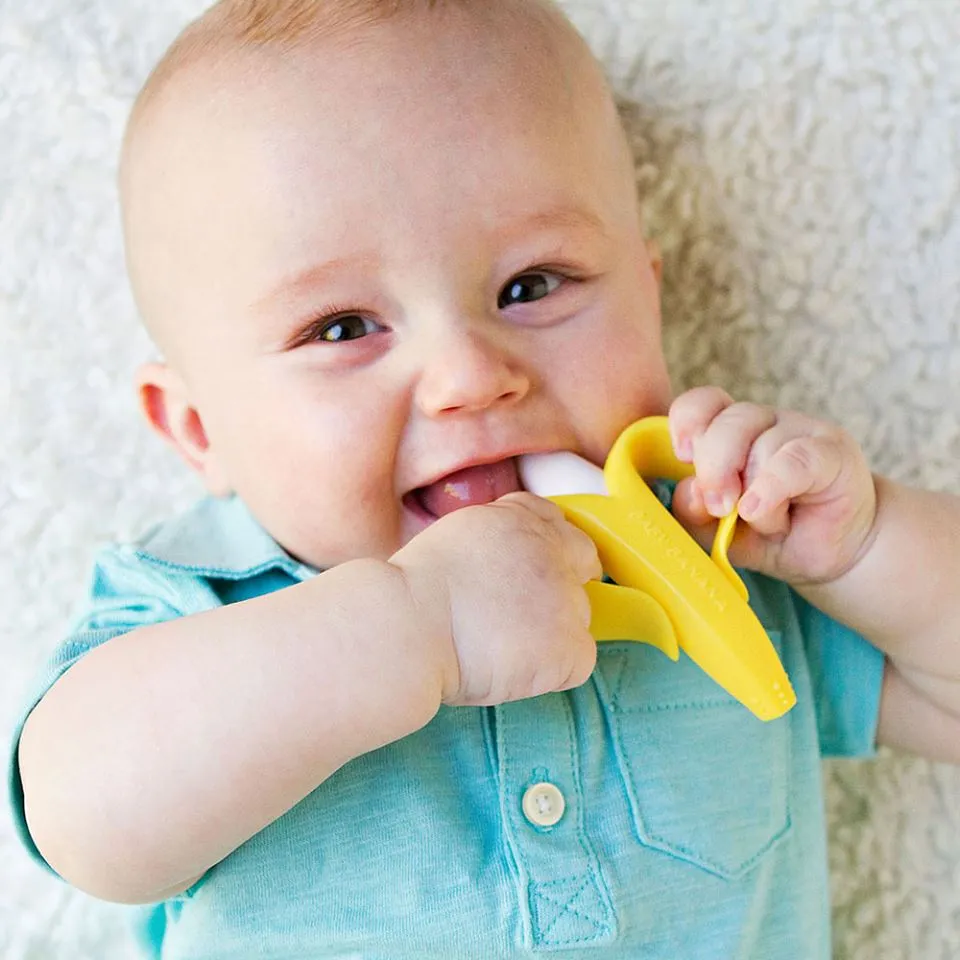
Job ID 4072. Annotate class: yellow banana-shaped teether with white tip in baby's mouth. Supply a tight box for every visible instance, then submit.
[521,417,796,720]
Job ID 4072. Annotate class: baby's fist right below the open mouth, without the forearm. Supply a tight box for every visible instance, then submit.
[391,493,602,706]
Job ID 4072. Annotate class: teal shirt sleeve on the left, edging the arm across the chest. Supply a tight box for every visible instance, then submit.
[8,547,189,869]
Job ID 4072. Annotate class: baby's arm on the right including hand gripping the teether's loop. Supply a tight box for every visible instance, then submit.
[670,387,960,763]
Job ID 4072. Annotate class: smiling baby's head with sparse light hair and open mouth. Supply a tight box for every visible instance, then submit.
[121,0,669,567]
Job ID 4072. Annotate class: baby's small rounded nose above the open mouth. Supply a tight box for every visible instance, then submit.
[416,327,530,417]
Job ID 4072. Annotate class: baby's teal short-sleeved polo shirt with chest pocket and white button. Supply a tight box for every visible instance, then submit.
[10,498,884,960]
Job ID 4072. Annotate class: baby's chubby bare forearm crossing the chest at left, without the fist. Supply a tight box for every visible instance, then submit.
[20,561,441,902]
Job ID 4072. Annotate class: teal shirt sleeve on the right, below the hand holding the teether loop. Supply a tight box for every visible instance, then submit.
[791,591,886,757]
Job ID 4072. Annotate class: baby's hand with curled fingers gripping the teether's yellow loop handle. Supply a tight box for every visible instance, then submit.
[670,387,877,586]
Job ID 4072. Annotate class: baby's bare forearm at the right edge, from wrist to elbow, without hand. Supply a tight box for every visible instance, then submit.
[798,478,960,696]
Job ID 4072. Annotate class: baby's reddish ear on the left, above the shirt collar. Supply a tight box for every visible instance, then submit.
[136,363,232,497]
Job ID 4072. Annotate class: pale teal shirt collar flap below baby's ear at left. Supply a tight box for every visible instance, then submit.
[134,496,318,580]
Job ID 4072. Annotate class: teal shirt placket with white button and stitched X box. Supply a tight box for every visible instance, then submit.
[494,694,616,951]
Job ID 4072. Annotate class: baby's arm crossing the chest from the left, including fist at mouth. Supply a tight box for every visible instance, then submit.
[19,494,600,903]
